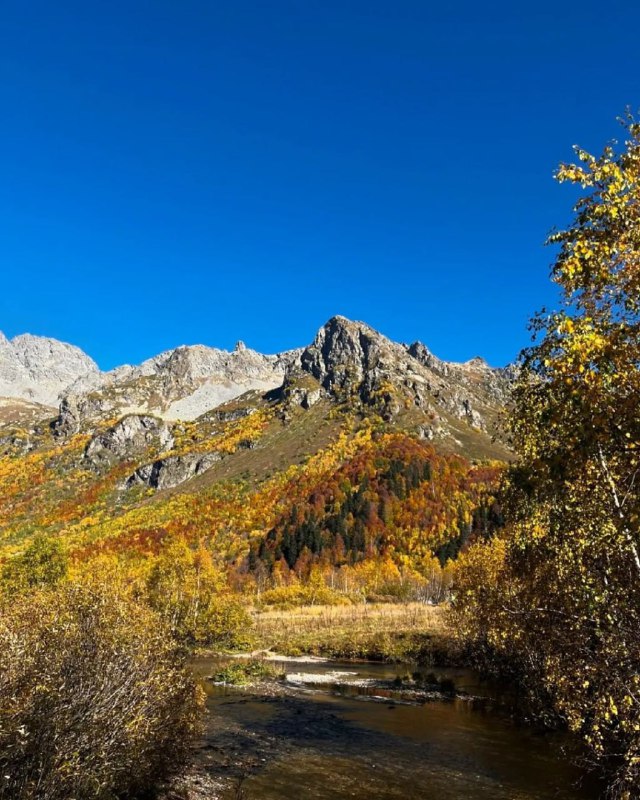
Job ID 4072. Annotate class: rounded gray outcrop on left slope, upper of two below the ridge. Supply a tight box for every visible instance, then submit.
[84,415,174,469]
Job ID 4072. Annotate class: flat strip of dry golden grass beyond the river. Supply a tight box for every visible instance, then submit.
[253,603,453,664]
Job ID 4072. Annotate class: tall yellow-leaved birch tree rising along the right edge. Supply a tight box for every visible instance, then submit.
[457,114,640,798]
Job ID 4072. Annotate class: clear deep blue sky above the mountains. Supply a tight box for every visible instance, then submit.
[0,0,640,368]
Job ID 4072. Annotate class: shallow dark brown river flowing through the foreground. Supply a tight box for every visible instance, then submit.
[190,659,599,800]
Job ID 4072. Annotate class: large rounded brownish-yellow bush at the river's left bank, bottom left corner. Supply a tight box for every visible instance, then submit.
[0,584,201,800]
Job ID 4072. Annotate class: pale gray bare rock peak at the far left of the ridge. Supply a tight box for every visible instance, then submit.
[0,333,98,407]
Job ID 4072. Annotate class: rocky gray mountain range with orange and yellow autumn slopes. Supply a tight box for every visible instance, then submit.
[0,317,514,582]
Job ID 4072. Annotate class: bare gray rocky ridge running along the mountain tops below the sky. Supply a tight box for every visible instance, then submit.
[0,317,514,450]
